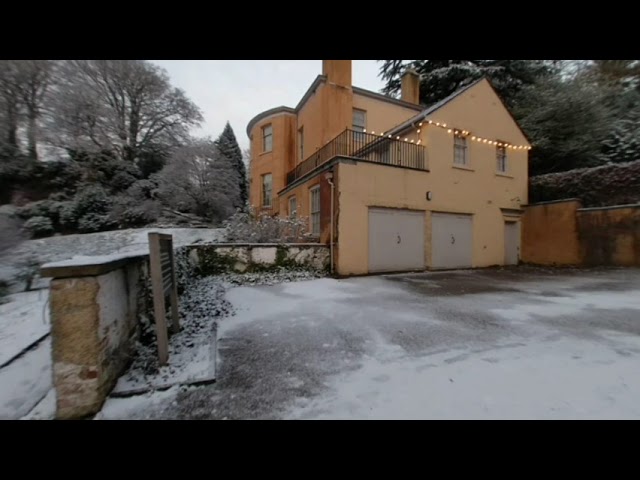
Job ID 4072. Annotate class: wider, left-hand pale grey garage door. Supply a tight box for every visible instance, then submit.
[369,208,425,273]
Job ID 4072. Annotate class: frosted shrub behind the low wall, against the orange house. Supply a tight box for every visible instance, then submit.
[224,211,316,243]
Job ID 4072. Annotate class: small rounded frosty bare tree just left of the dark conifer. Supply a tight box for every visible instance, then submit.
[157,139,240,221]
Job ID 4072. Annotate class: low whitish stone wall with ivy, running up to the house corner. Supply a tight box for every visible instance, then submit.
[184,243,330,275]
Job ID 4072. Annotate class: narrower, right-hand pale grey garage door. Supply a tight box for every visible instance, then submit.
[431,213,473,268]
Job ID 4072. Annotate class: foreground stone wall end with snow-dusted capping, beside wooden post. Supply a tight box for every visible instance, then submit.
[41,255,148,419]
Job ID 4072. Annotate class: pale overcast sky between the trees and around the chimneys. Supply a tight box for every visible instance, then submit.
[154,60,383,149]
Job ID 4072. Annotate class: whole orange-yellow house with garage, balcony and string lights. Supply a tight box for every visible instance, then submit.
[247,60,531,275]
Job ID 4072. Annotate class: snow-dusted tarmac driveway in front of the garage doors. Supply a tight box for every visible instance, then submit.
[101,268,640,419]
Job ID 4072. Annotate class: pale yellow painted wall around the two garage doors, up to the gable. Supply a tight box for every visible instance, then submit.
[337,82,528,275]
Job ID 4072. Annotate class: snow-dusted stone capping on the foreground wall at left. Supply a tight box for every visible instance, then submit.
[40,252,149,278]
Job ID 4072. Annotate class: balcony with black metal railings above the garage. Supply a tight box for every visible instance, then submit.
[287,129,428,185]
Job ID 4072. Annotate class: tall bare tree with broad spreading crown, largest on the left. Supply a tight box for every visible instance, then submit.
[54,60,202,161]
